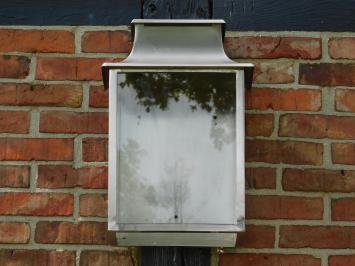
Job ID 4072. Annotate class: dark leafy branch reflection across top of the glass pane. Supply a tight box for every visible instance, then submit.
[120,73,235,149]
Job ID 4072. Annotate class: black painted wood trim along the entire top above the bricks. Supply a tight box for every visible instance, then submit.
[0,0,355,32]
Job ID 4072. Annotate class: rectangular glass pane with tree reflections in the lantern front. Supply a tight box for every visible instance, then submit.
[118,73,236,224]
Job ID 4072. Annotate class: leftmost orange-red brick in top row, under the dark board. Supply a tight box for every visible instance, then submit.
[0,29,75,53]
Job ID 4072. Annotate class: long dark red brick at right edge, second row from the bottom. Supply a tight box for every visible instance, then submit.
[279,225,355,249]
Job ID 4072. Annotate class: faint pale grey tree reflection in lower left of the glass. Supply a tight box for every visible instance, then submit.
[119,139,191,223]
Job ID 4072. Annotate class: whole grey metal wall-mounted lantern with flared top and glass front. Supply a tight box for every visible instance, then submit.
[102,20,253,247]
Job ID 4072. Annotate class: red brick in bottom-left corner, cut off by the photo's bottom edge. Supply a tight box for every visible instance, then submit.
[0,249,75,266]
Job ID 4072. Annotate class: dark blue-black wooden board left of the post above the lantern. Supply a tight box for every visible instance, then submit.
[0,0,141,25]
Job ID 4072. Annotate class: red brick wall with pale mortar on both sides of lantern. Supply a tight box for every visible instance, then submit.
[0,27,355,266]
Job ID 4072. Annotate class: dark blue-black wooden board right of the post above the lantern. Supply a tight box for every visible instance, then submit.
[213,0,355,31]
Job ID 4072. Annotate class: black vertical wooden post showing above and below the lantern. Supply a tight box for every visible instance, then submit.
[140,0,212,266]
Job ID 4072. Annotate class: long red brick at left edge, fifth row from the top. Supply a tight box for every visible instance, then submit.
[0,138,74,161]
